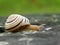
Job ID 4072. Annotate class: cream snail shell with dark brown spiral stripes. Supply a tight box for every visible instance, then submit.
[5,14,30,32]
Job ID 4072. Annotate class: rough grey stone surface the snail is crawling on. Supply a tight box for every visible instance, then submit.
[0,14,60,45]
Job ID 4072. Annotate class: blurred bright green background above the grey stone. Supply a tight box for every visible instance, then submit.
[0,0,60,16]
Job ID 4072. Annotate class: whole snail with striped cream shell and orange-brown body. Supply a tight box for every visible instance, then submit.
[5,14,45,32]
